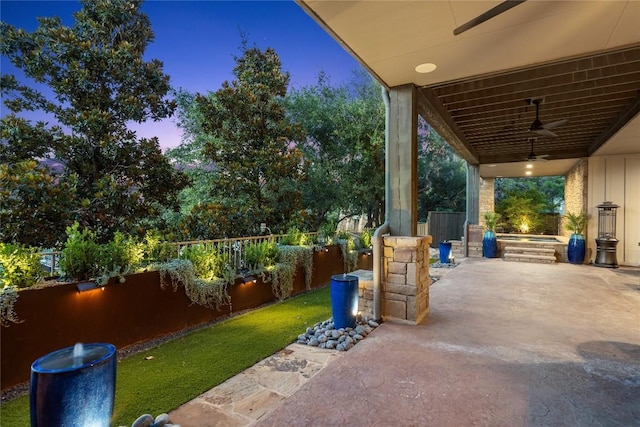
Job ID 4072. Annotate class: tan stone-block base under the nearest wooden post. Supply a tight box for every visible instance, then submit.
[381,236,431,325]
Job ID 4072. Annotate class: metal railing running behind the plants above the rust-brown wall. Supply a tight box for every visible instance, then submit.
[40,232,318,276]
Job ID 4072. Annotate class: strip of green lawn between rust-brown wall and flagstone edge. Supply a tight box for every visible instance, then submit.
[0,287,331,427]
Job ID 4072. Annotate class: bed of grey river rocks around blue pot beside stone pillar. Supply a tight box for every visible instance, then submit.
[296,316,379,351]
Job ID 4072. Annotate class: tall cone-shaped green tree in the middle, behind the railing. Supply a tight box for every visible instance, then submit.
[175,41,305,238]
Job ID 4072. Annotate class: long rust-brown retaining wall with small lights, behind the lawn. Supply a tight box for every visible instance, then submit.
[0,245,372,390]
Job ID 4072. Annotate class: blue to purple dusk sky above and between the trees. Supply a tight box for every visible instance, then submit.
[0,0,359,148]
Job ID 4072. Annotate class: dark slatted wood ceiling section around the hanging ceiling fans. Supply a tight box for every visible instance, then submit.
[420,46,640,164]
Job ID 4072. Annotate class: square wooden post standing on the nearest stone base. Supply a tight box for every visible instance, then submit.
[387,84,418,236]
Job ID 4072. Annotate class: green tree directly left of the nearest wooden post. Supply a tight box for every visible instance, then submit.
[287,71,385,229]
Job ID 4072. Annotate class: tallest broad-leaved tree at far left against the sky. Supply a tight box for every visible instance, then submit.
[0,0,186,244]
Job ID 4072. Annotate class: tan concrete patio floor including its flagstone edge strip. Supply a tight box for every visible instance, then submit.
[170,258,640,427]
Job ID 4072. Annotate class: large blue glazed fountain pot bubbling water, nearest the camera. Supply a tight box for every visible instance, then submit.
[29,343,117,427]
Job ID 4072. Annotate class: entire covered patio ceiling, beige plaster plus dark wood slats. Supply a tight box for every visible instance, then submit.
[297,0,640,177]
